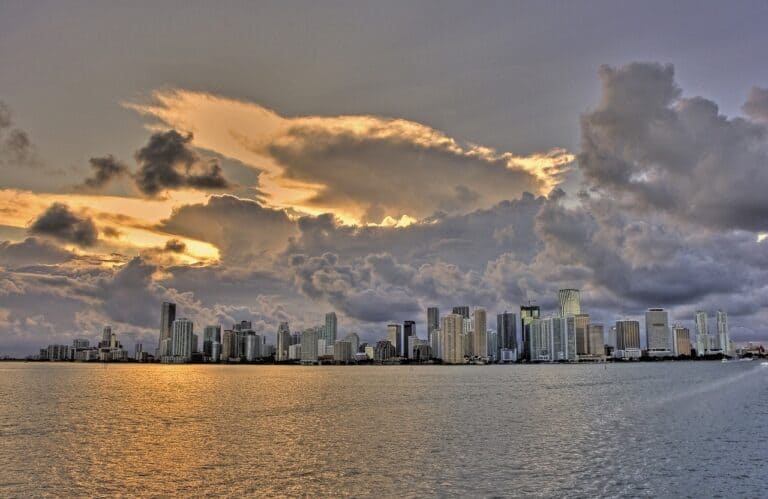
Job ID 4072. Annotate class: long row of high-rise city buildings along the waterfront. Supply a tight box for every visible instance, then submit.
[39,289,733,364]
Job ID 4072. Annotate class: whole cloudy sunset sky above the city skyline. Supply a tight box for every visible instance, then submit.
[0,0,768,355]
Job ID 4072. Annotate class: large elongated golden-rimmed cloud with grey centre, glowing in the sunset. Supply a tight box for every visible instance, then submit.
[129,90,573,223]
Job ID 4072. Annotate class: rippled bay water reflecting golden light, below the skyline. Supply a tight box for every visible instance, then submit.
[0,361,768,498]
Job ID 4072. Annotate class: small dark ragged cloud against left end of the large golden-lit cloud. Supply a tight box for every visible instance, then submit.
[135,130,229,196]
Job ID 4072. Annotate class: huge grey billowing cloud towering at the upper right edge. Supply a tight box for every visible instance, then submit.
[578,63,768,231]
